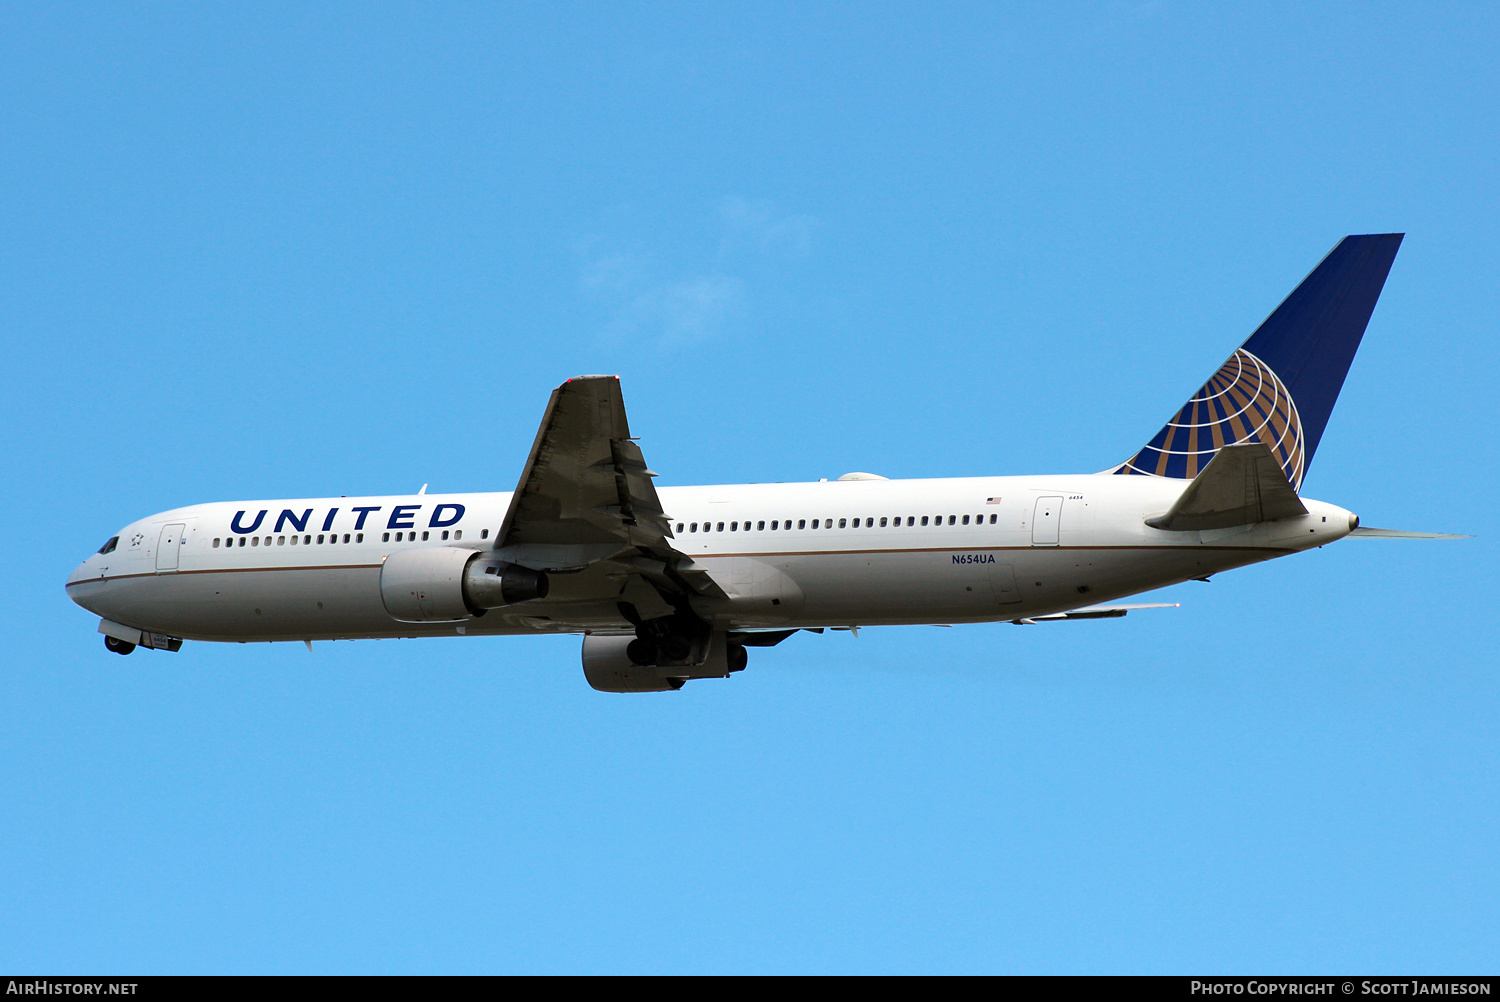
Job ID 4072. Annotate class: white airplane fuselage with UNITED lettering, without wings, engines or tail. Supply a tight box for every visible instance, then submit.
[68,474,1355,642]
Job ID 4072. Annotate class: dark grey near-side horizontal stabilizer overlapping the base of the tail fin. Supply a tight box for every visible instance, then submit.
[1146,441,1308,533]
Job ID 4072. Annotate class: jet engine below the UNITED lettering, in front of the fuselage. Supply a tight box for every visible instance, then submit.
[380,546,548,623]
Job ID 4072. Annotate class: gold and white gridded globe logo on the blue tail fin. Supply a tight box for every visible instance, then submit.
[1116,348,1305,491]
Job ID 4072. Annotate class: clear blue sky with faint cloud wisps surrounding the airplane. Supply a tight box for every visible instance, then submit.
[0,3,1500,974]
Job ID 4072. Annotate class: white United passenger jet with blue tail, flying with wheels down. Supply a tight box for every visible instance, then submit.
[66,234,1460,693]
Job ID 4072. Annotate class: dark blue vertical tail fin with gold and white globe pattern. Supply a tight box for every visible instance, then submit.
[1115,233,1406,491]
